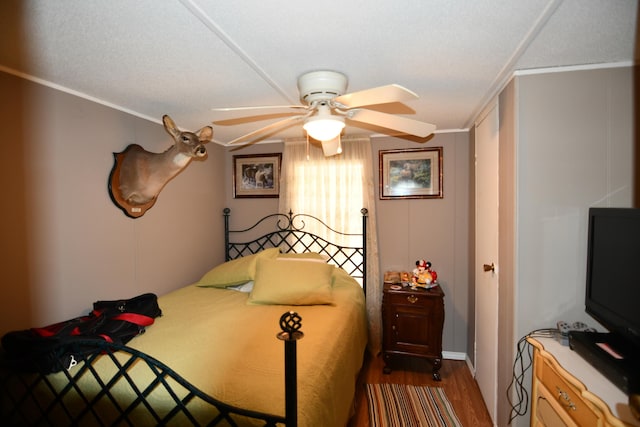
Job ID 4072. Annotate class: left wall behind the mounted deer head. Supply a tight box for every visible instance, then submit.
[0,73,224,334]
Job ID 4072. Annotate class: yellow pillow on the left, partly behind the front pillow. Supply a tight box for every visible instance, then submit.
[197,248,280,288]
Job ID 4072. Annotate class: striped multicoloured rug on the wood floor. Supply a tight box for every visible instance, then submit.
[366,384,462,427]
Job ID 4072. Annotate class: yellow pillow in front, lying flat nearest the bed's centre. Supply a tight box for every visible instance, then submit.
[248,258,335,305]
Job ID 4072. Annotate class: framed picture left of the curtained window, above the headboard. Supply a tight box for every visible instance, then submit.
[233,153,282,199]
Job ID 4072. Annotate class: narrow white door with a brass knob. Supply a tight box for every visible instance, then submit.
[474,104,499,424]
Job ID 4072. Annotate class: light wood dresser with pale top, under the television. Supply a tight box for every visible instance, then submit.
[527,338,640,427]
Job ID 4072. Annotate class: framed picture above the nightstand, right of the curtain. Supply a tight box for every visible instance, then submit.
[379,147,443,199]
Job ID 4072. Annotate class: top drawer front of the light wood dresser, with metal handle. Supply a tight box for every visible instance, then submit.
[536,357,600,426]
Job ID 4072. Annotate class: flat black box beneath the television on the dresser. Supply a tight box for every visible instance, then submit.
[569,331,640,395]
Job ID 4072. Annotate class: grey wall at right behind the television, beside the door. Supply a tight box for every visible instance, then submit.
[496,68,634,426]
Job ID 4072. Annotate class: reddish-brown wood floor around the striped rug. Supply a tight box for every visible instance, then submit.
[348,356,492,427]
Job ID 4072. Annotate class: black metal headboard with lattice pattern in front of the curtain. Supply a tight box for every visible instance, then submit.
[223,208,368,295]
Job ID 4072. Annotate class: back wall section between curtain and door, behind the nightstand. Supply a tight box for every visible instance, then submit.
[372,132,473,357]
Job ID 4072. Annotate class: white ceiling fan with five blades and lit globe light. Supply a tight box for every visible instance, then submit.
[213,70,436,156]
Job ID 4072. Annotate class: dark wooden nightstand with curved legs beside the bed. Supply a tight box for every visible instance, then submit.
[382,283,444,381]
